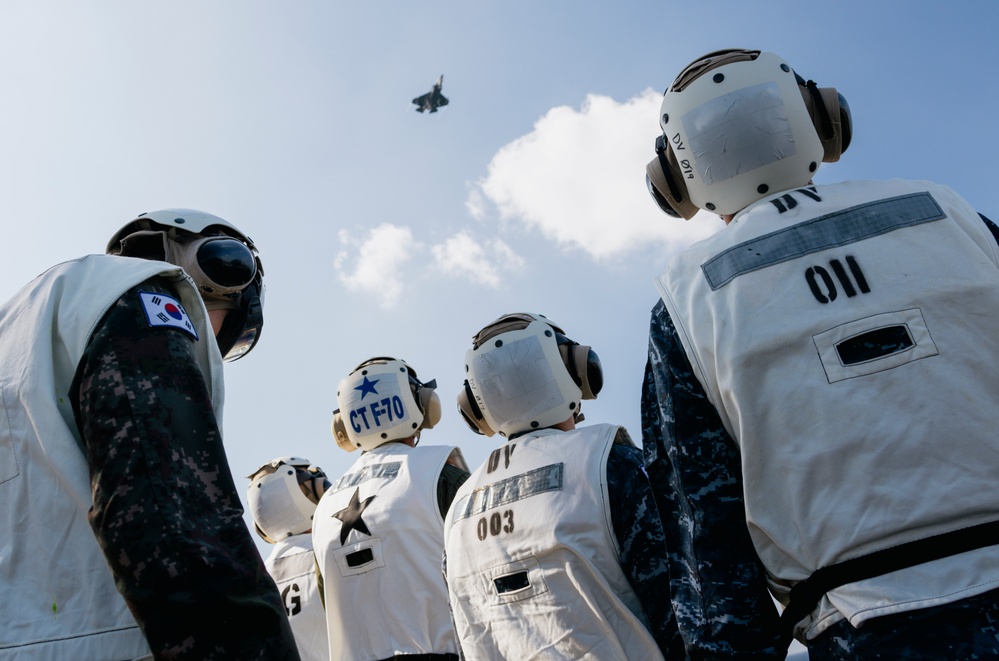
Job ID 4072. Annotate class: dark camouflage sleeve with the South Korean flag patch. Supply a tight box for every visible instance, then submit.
[71,279,299,661]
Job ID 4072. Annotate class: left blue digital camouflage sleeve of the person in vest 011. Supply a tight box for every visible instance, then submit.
[642,301,786,659]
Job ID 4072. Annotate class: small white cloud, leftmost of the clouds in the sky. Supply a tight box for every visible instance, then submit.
[333,223,422,308]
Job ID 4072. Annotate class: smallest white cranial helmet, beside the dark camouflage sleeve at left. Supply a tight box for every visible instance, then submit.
[246,457,330,544]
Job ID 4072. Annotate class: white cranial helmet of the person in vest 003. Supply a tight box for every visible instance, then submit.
[458,313,603,438]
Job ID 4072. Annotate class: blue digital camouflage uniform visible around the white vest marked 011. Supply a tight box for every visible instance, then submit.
[642,216,999,660]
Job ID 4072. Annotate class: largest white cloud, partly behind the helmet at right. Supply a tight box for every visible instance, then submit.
[466,89,721,259]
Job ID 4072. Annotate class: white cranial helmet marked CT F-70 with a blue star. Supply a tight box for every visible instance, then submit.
[333,357,441,452]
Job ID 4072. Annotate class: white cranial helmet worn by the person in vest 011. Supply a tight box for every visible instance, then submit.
[646,49,851,219]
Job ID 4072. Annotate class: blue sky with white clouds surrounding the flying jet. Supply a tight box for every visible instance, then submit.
[0,0,999,592]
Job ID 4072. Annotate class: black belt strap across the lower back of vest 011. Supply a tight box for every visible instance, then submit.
[780,521,999,645]
